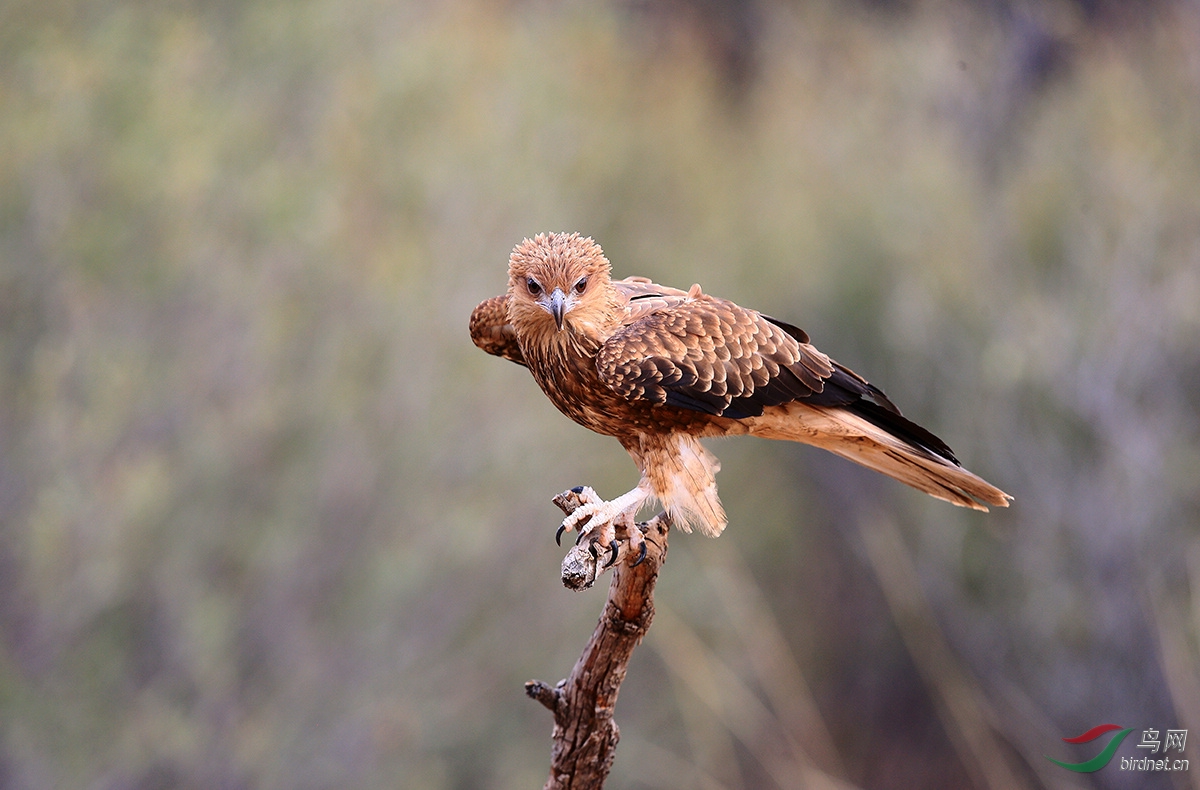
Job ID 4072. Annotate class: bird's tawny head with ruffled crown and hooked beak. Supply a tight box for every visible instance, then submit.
[509,233,616,336]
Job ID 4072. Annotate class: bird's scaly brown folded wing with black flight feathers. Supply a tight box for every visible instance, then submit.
[596,289,958,463]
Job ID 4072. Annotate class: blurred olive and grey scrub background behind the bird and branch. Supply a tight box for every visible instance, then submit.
[0,0,1200,790]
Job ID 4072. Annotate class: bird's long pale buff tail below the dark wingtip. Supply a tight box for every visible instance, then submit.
[744,402,1013,510]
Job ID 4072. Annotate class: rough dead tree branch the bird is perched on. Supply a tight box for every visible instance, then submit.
[526,491,671,790]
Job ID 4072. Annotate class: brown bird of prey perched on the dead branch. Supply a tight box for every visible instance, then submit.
[470,233,1012,564]
